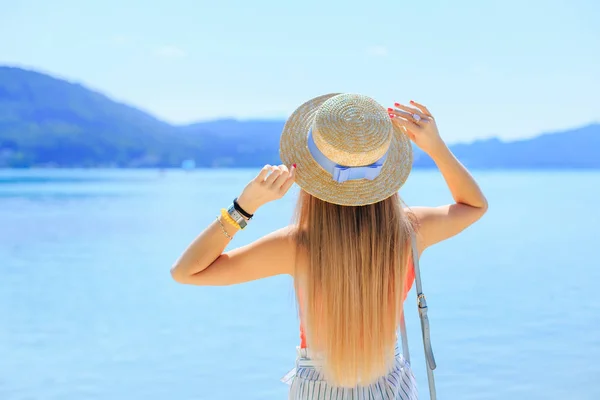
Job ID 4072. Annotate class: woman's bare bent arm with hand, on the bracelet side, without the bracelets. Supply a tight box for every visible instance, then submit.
[171,165,295,285]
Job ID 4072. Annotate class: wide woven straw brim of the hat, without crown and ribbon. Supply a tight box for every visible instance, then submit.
[279,93,413,206]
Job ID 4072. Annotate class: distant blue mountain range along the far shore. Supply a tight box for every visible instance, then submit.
[0,66,600,168]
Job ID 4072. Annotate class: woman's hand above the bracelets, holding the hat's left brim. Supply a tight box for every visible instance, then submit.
[238,164,296,214]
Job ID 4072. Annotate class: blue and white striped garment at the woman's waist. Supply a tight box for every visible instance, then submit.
[282,347,418,400]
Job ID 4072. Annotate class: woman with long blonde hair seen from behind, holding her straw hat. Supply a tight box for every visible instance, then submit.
[171,94,487,399]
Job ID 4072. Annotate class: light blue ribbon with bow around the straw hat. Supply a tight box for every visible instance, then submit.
[307,130,387,183]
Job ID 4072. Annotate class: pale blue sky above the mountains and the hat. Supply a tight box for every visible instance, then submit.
[0,0,600,142]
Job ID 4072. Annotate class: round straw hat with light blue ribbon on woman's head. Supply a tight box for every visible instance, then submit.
[279,93,413,206]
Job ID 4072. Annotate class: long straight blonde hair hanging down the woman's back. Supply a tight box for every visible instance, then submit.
[295,191,414,387]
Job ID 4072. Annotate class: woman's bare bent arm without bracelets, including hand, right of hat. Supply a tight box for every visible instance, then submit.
[392,102,488,251]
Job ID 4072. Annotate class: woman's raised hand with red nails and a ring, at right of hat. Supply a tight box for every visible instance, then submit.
[388,101,446,156]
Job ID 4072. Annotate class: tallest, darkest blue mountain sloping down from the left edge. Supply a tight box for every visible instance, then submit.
[0,67,204,167]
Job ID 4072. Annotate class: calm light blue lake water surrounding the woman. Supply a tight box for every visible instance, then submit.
[0,170,600,400]
